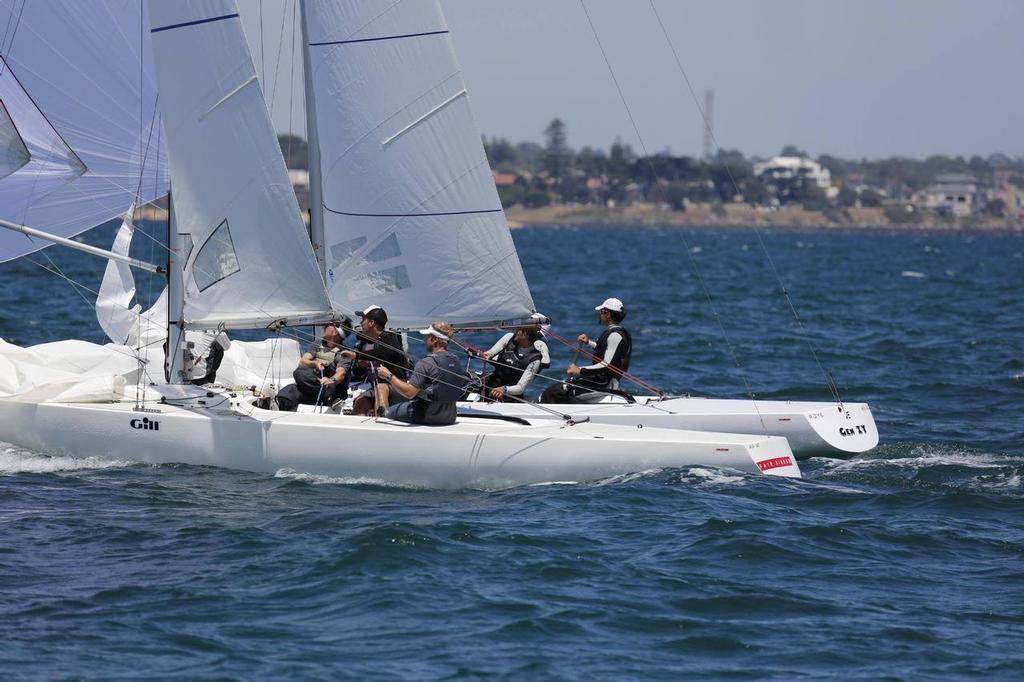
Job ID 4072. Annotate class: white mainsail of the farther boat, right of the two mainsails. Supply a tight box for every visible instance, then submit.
[302,0,534,328]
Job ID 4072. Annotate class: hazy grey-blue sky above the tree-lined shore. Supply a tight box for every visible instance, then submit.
[240,0,1024,158]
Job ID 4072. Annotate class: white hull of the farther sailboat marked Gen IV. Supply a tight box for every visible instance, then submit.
[459,397,879,459]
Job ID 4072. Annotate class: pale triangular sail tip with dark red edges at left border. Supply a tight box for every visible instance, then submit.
[0,57,86,195]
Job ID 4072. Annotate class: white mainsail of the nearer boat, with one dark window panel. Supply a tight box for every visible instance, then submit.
[150,0,331,329]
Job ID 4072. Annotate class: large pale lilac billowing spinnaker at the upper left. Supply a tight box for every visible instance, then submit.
[0,0,167,261]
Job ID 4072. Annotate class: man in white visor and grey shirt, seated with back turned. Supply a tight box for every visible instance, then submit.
[377,322,466,426]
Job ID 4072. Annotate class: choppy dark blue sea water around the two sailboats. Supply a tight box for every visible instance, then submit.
[0,228,1024,680]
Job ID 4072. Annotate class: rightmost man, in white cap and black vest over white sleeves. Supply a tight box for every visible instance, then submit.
[541,298,633,402]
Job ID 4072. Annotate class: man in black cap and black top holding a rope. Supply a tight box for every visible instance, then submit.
[342,305,409,415]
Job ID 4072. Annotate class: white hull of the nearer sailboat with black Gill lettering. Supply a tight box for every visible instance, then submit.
[0,393,800,488]
